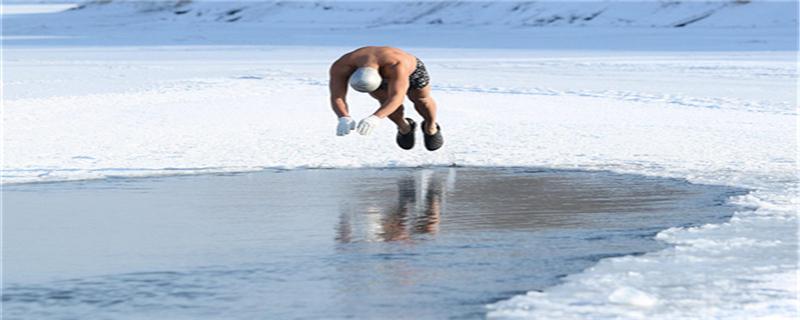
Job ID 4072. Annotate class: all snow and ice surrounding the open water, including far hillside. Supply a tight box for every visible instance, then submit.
[2,1,800,319]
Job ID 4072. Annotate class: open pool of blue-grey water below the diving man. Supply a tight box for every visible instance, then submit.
[3,168,745,319]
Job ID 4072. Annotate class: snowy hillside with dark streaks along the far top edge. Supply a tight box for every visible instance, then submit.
[50,0,797,27]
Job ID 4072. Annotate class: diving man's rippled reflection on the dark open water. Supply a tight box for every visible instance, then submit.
[337,175,444,243]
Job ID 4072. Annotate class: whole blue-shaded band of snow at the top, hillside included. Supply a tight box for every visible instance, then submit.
[3,0,798,51]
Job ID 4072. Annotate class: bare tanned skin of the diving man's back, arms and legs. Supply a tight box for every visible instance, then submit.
[330,47,437,135]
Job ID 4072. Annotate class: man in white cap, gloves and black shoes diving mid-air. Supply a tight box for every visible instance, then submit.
[329,47,444,151]
